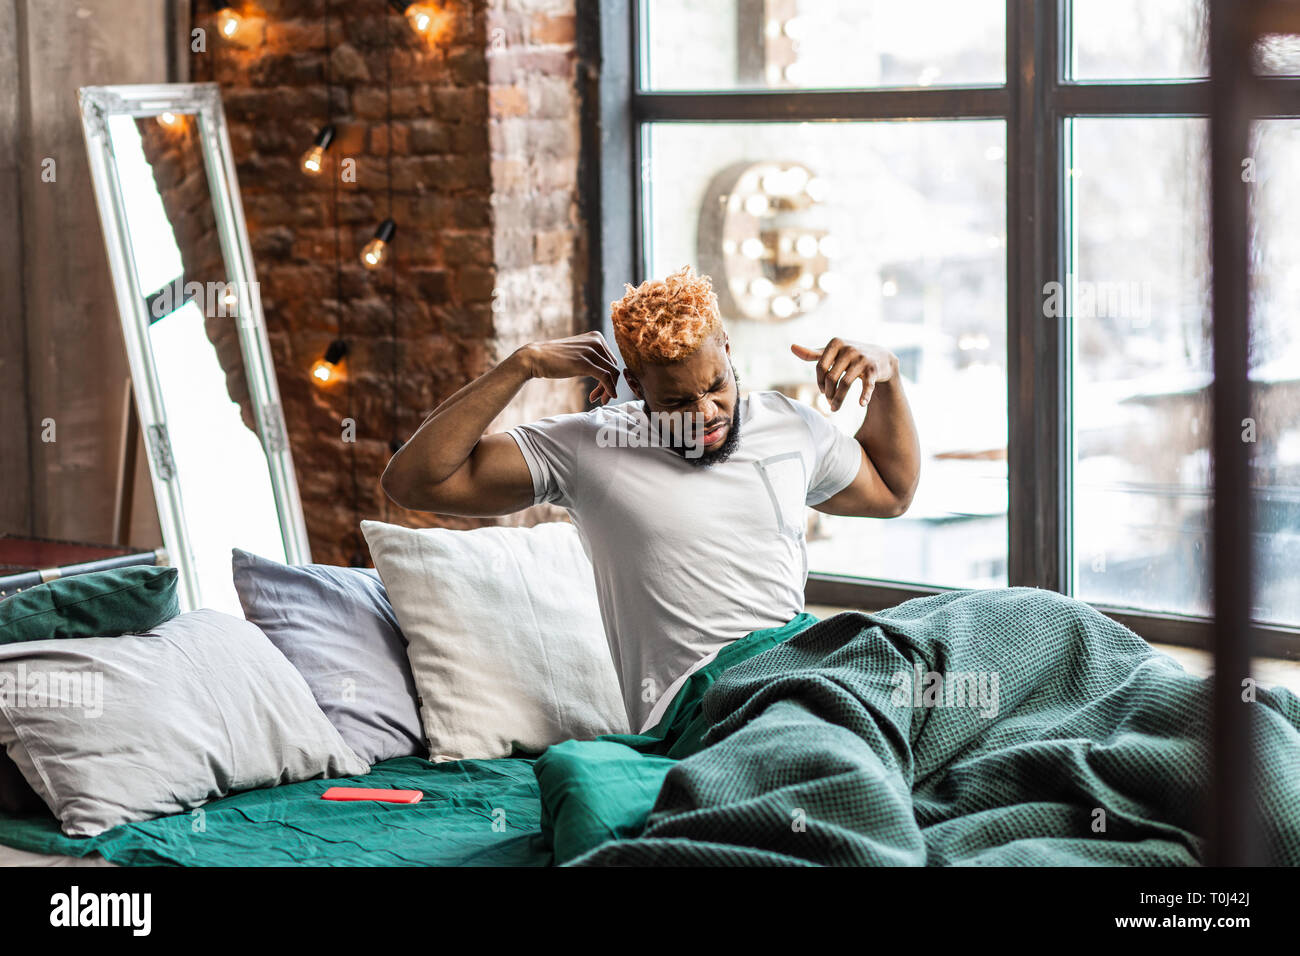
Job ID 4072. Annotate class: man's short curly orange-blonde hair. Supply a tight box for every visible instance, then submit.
[610,265,723,373]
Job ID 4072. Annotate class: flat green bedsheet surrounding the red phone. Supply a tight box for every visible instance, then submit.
[0,757,551,866]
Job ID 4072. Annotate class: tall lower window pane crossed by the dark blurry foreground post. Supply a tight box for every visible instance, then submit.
[1071,118,1300,623]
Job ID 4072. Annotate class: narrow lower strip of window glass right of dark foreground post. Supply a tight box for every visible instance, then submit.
[1242,120,1300,624]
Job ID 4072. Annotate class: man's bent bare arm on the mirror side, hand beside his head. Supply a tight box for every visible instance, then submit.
[384,332,619,515]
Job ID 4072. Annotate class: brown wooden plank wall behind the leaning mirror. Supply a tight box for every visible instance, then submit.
[0,0,175,546]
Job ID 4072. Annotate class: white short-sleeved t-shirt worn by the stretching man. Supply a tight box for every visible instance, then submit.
[507,392,862,728]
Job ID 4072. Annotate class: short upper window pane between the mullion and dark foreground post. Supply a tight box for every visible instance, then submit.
[1070,0,1209,79]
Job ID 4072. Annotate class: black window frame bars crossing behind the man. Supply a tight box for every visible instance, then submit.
[580,0,1300,659]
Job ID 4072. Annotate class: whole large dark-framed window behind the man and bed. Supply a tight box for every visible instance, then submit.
[602,0,1300,649]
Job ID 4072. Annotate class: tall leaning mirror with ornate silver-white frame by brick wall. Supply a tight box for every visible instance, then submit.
[79,83,311,614]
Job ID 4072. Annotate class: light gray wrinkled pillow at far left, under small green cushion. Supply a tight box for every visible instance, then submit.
[0,609,369,836]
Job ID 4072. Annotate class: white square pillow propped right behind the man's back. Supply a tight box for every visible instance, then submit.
[361,522,628,761]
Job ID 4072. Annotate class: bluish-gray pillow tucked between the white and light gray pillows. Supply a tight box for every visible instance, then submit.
[231,549,428,763]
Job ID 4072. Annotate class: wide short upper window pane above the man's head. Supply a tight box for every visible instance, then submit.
[641,0,1006,90]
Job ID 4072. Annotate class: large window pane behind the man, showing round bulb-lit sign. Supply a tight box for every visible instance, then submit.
[646,121,1006,587]
